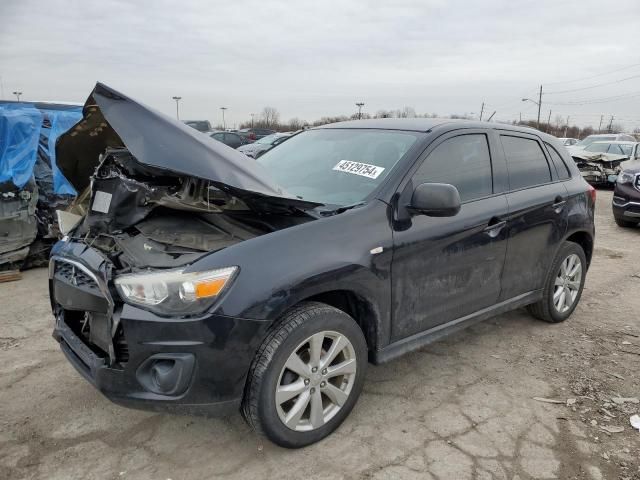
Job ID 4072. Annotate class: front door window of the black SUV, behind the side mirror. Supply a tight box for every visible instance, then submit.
[413,134,493,202]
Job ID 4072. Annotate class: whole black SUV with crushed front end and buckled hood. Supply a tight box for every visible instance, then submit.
[50,84,595,447]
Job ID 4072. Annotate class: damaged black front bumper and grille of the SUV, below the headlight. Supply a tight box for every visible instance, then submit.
[49,242,268,415]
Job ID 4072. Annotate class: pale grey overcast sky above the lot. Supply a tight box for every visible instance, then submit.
[0,0,640,129]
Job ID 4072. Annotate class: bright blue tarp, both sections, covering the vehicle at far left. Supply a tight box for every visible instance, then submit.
[0,102,82,195]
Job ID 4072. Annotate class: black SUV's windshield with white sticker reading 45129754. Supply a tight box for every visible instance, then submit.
[257,129,419,206]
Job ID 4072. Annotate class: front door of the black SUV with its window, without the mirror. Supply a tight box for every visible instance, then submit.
[391,130,508,341]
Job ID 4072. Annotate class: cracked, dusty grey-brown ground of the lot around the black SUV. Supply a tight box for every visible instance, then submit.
[0,191,640,480]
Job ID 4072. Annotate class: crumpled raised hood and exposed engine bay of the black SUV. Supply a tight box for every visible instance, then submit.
[56,83,319,273]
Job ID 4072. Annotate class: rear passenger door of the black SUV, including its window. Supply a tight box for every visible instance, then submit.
[499,131,567,300]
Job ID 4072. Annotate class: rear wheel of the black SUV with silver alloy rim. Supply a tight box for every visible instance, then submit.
[527,242,587,323]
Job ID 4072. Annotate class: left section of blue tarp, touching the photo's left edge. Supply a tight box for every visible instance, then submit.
[0,103,44,188]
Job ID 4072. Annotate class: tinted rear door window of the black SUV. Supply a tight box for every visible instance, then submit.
[500,135,551,190]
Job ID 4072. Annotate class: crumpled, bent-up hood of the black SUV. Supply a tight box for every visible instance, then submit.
[56,82,318,209]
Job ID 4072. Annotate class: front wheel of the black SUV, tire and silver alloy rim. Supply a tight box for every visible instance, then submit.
[242,302,367,448]
